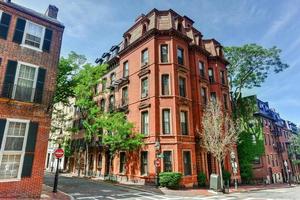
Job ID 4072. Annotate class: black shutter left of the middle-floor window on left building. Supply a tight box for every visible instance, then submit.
[2,60,18,98]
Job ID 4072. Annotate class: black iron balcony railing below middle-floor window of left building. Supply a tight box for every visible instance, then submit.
[0,84,54,107]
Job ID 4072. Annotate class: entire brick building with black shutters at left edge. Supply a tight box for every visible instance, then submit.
[0,0,64,198]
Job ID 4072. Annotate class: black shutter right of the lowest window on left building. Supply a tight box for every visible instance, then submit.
[21,122,39,178]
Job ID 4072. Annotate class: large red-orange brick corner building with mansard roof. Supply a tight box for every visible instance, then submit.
[71,9,240,186]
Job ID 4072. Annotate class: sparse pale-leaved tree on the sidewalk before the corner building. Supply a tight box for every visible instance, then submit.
[202,102,238,188]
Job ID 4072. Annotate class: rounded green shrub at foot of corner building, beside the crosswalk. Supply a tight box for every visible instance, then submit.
[159,172,182,189]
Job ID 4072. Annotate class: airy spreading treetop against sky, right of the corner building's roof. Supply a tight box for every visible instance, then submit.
[224,44,288,112]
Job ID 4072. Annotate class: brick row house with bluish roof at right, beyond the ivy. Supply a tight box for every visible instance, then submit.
[246,96,299,183]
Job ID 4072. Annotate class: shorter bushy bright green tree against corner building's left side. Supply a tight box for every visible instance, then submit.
[101,112,144,178]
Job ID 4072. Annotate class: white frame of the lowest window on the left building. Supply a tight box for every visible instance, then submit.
[0,118,30,182]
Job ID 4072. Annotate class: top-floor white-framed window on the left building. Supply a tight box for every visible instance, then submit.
[23,21,45,49]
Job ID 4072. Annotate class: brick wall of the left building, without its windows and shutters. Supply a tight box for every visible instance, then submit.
[0,1,64,198]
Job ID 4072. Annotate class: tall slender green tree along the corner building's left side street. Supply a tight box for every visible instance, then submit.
[74,63,106,175]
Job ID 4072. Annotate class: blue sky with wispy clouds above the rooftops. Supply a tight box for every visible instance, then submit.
[12,0,300,125]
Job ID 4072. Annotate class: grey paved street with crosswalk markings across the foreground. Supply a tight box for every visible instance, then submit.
[44,174,300,200]
